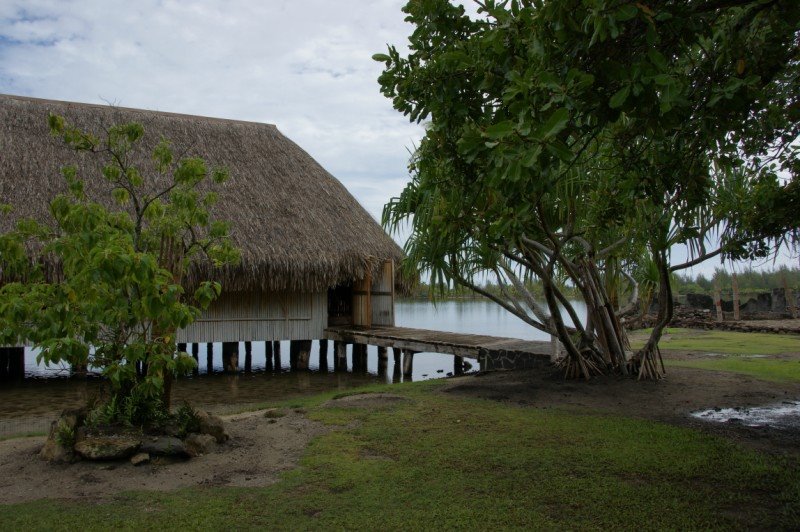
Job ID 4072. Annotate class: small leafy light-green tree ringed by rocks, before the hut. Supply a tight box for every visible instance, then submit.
[0,116,238,423]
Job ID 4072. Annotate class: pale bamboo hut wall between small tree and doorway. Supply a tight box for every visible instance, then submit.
[177,292,328,343]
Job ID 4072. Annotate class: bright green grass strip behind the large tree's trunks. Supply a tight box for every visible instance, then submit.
[631,327,800,355]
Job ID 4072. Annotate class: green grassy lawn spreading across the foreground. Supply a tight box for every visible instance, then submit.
[0,382,800,530]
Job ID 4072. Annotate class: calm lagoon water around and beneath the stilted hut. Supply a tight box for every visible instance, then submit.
[0,299,585,437]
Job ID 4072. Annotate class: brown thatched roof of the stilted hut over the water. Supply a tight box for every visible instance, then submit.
[0,95,401,291]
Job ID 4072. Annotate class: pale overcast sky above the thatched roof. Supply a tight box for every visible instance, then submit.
[0,0,797,278]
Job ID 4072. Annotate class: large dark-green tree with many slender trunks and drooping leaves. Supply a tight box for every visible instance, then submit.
[374,0,800,377]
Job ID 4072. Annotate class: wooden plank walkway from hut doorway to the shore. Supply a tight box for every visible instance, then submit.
[325,327,551,362]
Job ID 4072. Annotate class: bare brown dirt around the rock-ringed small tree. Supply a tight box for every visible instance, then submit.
[0,411,330,504]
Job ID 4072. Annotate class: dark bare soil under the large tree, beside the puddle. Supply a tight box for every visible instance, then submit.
[443,367,800,459]
